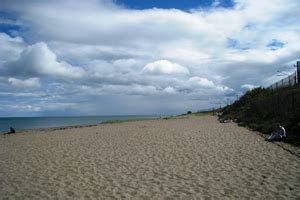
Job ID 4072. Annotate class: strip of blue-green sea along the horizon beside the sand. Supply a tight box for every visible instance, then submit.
[0,115,159,133]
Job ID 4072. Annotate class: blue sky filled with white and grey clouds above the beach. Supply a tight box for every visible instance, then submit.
[0,0,300,117]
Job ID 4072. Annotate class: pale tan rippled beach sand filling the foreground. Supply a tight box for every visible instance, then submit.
[0,116,300,199]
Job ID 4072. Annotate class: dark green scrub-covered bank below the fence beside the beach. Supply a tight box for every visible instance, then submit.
[220,85,300,146]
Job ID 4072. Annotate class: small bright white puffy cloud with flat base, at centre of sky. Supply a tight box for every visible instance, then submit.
[143,60,189,75]
